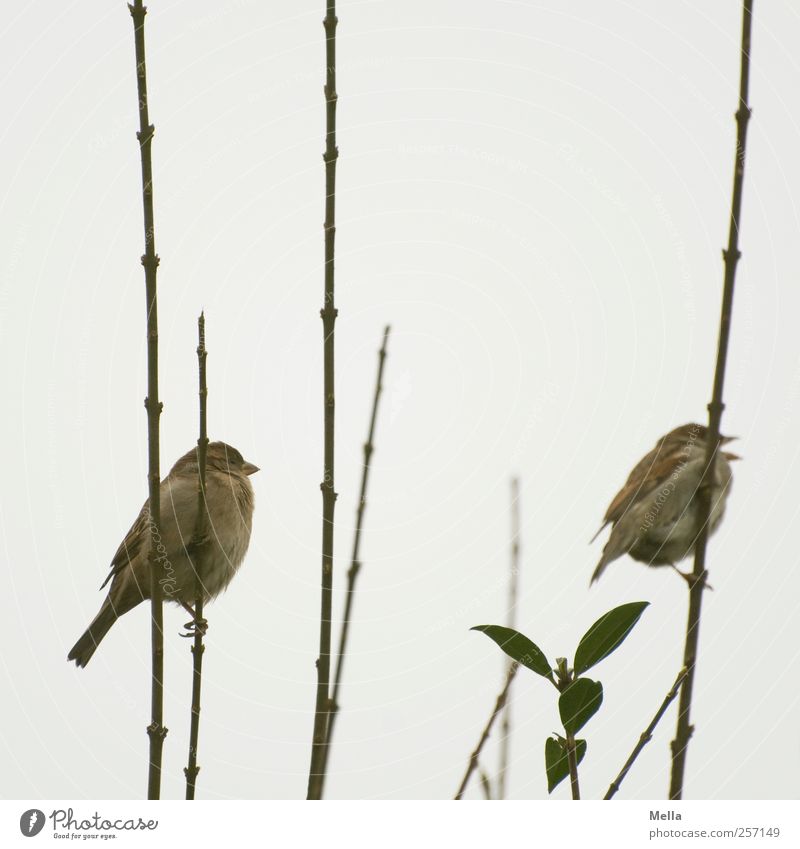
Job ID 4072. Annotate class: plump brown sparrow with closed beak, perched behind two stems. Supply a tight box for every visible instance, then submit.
[67,442,259,667]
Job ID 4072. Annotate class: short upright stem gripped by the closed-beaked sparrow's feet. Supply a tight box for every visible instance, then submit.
[183,313,208,800]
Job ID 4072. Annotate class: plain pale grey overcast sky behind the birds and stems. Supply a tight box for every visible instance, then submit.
[0,0,800,799]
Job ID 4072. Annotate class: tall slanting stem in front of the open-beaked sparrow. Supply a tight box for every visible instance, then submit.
[669,0,753,799]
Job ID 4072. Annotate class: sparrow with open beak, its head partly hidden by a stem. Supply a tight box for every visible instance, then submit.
[591,424,739,583]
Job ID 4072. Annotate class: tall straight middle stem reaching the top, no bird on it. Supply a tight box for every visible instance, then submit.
[308,0,339,799]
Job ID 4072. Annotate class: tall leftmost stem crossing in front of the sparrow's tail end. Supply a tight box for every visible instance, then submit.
[128,0,167,799]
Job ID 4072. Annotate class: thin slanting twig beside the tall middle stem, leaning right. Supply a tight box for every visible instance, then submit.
[320,325,391,795]
